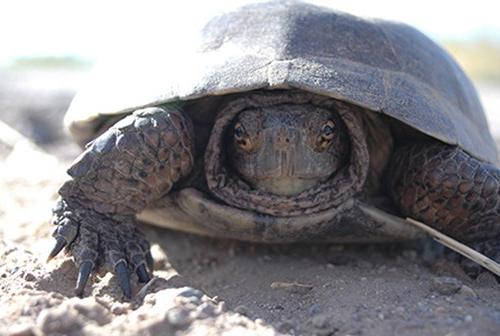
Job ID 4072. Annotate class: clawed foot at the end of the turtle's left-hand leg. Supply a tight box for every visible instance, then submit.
[49,200,153,298]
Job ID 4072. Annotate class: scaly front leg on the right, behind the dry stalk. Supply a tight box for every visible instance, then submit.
[387,143,500,275]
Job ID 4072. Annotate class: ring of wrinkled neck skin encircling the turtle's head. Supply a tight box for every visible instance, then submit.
[201,90,369,217]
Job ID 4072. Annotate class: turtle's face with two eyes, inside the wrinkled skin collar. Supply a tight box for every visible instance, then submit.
[227,104,350,196]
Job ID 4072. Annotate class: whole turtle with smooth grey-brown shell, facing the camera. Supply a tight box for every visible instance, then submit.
[49,1,500,297]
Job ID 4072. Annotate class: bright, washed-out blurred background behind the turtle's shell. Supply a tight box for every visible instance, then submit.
[0,0,500,159]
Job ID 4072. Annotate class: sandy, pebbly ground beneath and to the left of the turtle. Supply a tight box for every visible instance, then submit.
[0,72,500,336]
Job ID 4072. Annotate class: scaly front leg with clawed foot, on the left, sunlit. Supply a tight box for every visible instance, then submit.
[49,108,193,297]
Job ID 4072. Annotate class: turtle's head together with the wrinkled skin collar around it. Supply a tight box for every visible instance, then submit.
[204,90,369,217]
